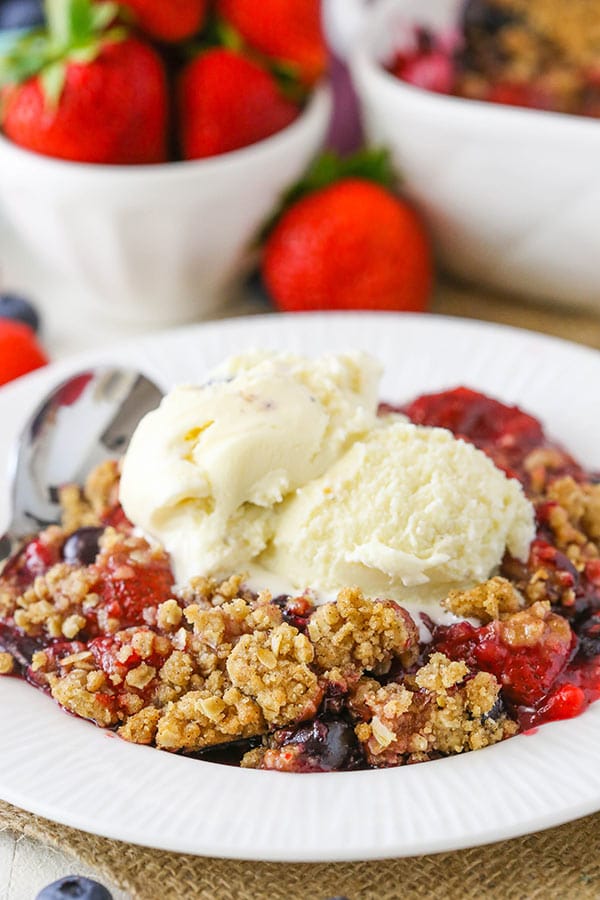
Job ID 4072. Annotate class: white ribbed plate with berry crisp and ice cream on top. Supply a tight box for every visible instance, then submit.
[0,314,600,861]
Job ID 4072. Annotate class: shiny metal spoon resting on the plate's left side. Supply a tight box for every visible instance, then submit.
[0,367,163,563]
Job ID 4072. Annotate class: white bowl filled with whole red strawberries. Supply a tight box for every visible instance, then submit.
[0,0,330,324]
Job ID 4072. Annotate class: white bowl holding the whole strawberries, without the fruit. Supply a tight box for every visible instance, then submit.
[0,87,331,324]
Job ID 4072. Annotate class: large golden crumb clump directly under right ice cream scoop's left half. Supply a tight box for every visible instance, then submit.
[308,588,418,674]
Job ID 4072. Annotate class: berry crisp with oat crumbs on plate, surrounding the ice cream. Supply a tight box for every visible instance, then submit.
[0,388,600,772]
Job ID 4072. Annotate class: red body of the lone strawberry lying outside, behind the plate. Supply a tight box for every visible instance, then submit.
[262,157,432,312]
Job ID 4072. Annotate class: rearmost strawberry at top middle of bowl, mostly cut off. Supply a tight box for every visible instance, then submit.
[113,0,207,43]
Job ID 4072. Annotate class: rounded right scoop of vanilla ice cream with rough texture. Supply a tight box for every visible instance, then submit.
[259,416,534,600]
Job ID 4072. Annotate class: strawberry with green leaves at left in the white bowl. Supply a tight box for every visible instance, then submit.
[0,0,167,165]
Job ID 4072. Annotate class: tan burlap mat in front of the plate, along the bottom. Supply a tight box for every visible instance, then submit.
[0,803,600,900]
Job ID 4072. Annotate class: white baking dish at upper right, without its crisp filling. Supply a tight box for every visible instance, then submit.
[352,0,600,310]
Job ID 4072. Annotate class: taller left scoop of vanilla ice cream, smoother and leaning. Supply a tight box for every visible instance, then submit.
[121,353,380,582]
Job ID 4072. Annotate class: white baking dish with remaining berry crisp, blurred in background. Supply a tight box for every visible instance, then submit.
[353,0,600,309]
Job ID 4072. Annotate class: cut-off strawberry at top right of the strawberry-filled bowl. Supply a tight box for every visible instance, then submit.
[217,0,327,85]
